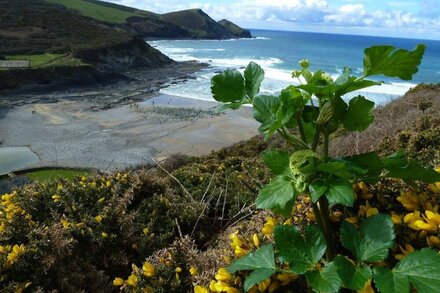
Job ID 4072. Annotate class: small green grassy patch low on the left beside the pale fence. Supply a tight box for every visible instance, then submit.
[6,53,86,68]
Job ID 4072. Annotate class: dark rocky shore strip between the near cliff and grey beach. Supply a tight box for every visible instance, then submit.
[0,61,209,110]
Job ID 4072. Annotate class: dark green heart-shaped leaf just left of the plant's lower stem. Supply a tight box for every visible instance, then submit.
[274,225,327,274]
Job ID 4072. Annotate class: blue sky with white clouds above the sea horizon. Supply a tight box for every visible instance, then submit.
[106,0,440,40]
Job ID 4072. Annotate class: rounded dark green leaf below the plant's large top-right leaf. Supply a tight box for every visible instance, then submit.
[343,96,374,131]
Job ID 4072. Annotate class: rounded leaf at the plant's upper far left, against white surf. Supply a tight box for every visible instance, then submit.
[211,70,245,103]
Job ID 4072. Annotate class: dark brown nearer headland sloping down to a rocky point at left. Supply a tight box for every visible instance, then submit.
[0,0,172,70]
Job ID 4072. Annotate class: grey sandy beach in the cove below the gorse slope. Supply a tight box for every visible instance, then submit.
[0,73,258,171]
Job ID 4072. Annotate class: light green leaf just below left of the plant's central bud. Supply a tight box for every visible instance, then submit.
[256,176,297,215]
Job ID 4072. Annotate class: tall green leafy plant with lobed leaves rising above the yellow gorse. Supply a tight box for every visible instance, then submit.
[211,45,440,293]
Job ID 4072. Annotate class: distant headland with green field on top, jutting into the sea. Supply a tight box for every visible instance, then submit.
[46,0,252,39]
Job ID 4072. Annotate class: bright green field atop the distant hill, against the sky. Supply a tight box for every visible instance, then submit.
[46,0,142,23]
